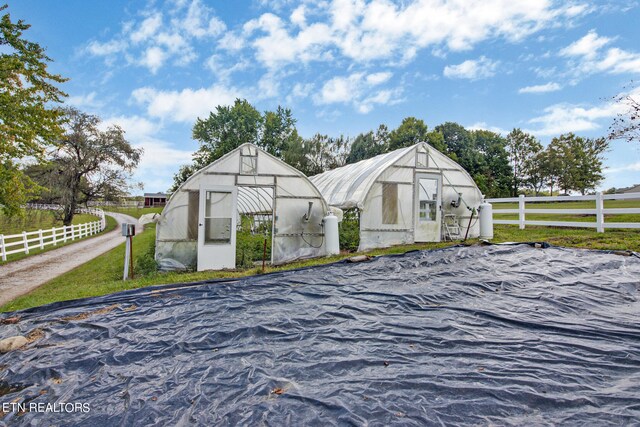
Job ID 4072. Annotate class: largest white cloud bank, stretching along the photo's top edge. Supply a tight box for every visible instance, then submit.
[238,0,591,68]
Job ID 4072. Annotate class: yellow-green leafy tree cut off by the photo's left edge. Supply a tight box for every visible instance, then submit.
[0,5,67,215]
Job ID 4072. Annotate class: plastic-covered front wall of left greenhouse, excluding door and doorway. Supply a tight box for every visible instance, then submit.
[156,144,327,270]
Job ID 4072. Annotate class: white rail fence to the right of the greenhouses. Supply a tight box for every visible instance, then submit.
[487,192,640,233]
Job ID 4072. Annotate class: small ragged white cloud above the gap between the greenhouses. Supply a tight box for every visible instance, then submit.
[314,72,403,114]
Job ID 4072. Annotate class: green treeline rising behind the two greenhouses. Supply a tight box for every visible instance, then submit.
[170,99,608,197]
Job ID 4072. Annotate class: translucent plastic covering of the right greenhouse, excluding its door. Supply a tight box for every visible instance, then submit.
[309,142,482,250]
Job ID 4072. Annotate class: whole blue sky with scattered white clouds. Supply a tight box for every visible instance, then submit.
[5,0,640,192]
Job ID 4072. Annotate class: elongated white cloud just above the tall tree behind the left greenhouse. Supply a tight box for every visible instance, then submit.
[132,85,241,123]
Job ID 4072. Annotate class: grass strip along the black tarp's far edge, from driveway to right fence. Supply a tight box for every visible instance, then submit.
[0,203,640,311]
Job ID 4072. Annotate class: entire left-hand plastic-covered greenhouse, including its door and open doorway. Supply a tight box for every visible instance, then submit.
[155,144,327,270]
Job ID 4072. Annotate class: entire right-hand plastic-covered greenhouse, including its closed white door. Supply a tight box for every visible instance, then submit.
[309,142,482,250]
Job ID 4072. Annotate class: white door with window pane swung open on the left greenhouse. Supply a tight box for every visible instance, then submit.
[198,186,238,271]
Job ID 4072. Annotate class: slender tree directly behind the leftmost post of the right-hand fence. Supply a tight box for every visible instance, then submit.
[507,129,542,196]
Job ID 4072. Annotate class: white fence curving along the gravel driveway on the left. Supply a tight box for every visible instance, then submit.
[0,204,106,261]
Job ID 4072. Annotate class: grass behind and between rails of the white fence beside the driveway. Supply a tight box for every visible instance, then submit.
[0,210,118,266]
